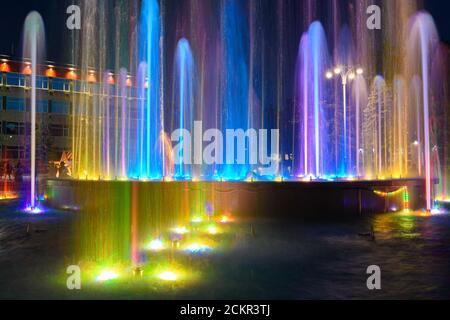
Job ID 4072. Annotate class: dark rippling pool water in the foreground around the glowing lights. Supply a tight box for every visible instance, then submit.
[0,203,450,299]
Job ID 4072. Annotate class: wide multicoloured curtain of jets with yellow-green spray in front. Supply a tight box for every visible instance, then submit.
[30,0,445,275]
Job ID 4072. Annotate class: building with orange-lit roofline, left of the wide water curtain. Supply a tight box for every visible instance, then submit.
[0,57,72,174]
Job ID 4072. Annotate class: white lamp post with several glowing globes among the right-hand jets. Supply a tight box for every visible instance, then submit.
[326,66,364,173]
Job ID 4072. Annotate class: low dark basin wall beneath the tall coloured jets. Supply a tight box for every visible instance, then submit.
[46,179,426,218]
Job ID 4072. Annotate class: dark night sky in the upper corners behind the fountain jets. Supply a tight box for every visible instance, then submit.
[0,0,450,62]
